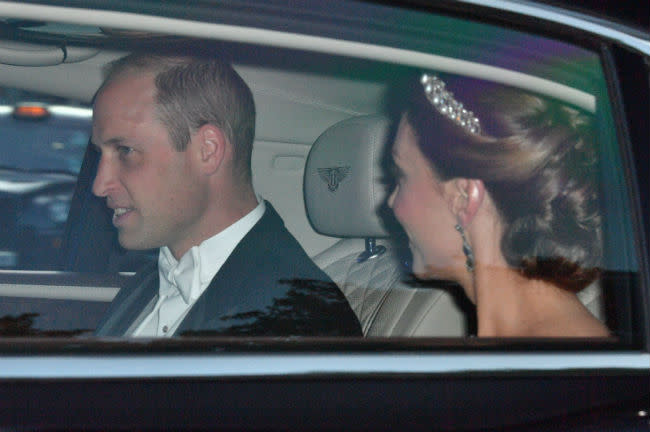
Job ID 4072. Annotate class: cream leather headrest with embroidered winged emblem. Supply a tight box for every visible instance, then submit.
[304,115,390,238]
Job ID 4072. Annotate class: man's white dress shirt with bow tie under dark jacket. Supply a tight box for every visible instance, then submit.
[131,199,266,337]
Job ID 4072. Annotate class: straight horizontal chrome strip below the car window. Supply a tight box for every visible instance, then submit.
[0,352,650,379]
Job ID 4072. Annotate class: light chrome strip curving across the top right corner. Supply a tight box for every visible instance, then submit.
[457,0,650,55]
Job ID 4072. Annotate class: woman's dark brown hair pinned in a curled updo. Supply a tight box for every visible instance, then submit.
[404,73,602,291]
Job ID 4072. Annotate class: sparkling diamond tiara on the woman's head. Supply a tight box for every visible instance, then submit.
[420,74,481,134]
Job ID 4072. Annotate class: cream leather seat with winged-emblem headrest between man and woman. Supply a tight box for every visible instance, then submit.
[304,115,603,337]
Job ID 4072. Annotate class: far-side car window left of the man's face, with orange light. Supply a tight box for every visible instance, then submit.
[0,88,91,270]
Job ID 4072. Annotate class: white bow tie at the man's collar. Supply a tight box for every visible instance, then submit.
[158,246,201,305]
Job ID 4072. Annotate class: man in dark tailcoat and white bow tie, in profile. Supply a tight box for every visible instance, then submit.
[92,55,361,337]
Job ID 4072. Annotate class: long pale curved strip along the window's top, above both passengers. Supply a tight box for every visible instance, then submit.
[0,1,596,112]
